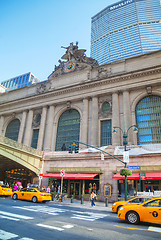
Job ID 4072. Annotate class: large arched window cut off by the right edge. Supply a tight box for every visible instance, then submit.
[135,95,161,145]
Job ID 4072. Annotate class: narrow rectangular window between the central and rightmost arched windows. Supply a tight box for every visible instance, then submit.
[101,120,112,146]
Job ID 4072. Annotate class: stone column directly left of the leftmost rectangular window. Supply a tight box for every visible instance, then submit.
[23,110,33,146]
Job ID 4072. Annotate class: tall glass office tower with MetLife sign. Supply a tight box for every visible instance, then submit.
[91,0,161,64]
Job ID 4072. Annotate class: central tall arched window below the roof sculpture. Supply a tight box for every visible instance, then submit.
[55,109,80,151]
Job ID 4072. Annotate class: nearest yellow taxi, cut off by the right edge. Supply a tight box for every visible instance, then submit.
[118,198,161,224]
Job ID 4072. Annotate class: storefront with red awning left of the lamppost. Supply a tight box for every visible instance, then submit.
[43,173,100,199]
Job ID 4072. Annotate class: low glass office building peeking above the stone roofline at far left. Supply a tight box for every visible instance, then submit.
[1,72,40,91]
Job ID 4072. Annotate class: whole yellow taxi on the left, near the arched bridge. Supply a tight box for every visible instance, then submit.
[11,188,51,203]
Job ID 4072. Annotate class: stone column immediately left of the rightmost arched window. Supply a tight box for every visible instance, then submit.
[123,90,133,145]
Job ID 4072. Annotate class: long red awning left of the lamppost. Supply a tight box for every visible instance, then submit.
[43,173,98,179]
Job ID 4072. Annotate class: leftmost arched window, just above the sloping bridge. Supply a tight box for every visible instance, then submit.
[5,119,20,141]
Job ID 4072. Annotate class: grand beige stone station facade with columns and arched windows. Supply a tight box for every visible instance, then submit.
[0,43,161,201]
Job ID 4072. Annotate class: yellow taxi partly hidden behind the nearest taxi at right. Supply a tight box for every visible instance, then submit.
[112,196,152,213]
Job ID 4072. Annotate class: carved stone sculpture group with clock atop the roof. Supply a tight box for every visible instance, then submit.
[48,42,98,79]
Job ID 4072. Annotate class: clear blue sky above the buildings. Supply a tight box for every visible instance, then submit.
[0,0,118,83]
